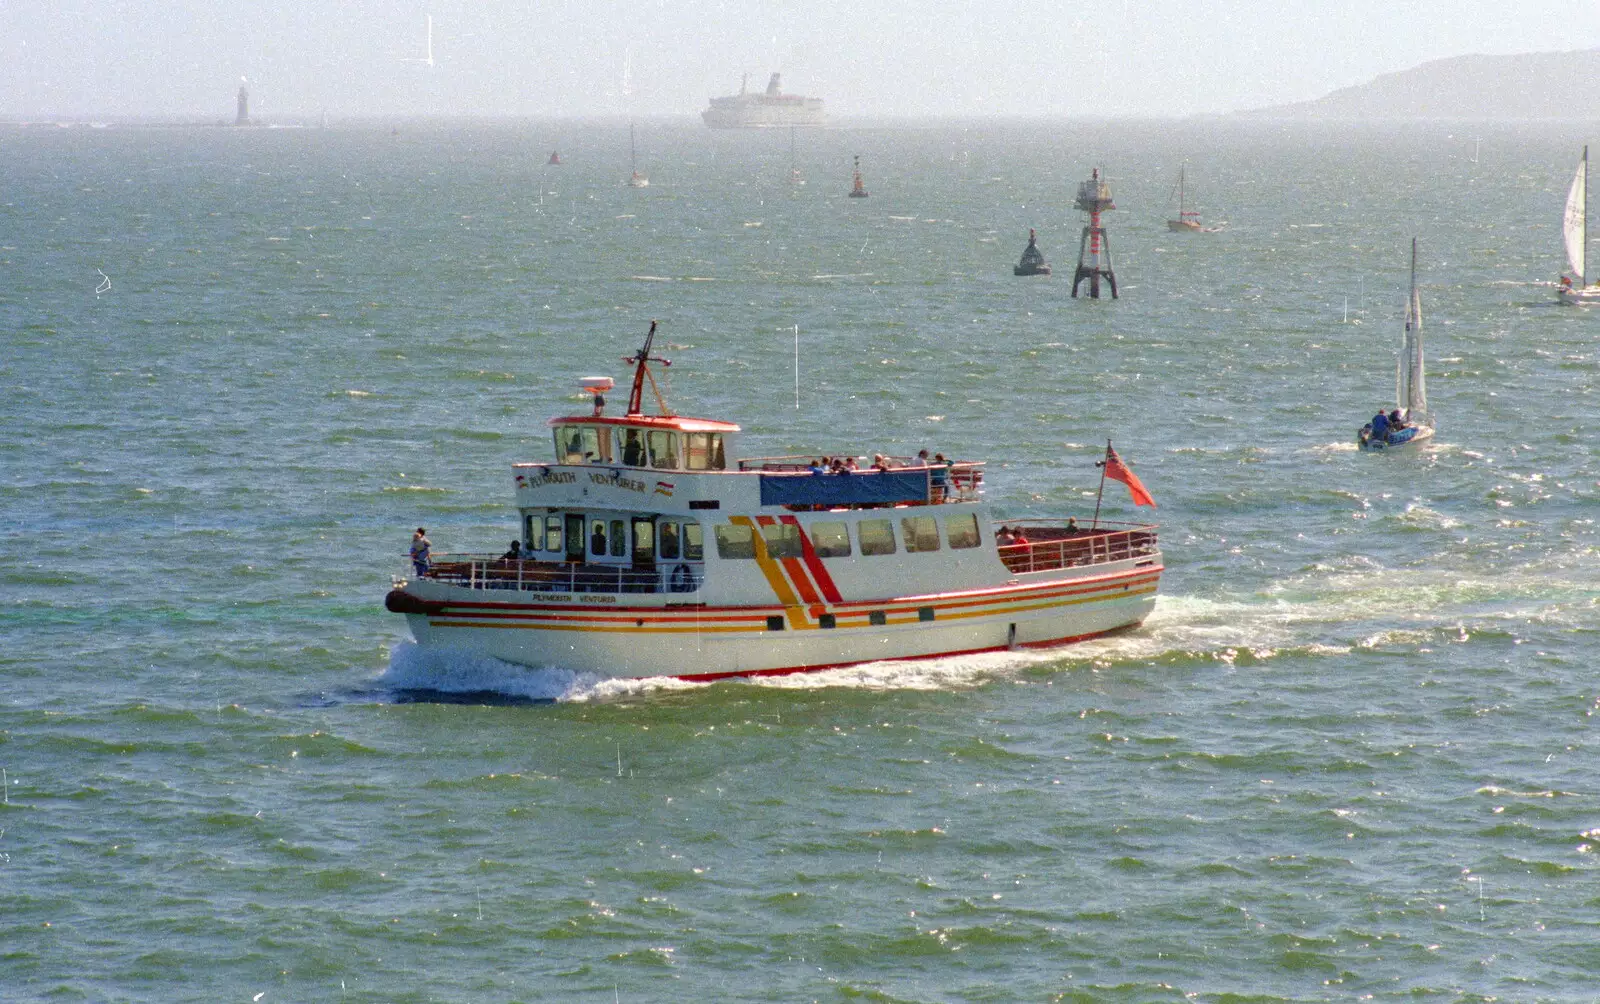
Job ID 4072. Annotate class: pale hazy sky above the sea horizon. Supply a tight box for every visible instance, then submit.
[0,0,1600,120]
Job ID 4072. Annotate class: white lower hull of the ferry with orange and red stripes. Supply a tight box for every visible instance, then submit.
[390,556,1162,679]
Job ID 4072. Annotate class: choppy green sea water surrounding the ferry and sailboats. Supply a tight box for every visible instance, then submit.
[0,123,1600,1002]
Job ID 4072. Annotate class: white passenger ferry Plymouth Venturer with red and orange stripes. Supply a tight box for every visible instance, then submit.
[386,323,1162,679]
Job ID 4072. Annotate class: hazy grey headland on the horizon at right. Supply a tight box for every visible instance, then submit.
[1235,48,1600,122]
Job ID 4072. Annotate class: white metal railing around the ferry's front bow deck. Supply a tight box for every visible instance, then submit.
[406,555,706,593]
